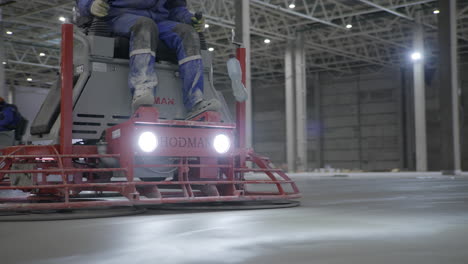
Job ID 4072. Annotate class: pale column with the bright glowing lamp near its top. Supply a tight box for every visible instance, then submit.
[413,18,427,172]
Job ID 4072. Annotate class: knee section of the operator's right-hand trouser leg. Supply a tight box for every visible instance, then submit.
[173,24,201,64]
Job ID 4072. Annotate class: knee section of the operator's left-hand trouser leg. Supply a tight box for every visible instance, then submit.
[130,17,159,57]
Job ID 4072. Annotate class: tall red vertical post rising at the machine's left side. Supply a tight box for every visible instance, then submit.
[60,24,73,158]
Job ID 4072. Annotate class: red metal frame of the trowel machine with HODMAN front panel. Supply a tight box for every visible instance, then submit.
[0,24,300,210]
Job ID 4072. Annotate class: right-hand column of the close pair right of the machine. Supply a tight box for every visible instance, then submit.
[294,34,308,172]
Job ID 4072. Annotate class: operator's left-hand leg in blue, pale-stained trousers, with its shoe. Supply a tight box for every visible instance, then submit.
[113,14,158,111]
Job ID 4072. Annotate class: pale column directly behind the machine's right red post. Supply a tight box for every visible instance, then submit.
[235,0,253,148]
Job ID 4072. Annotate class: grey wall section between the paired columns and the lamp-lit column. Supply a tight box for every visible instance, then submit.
[309,70,402,171]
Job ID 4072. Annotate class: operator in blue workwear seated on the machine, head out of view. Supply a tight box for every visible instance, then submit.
[77,0,220,117]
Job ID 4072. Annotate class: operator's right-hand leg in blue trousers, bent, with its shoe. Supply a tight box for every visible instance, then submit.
[158,21,220,115]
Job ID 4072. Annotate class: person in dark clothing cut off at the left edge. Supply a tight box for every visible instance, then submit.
[0,97,27,147]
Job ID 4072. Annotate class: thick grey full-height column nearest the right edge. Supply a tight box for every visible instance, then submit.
[438,0,461,174]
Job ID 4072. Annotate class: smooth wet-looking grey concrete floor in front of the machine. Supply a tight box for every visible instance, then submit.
[0,176,468,264]
